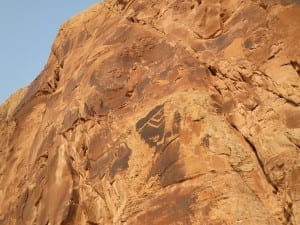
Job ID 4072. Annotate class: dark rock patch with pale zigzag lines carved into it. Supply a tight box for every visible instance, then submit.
[136,104,165,147]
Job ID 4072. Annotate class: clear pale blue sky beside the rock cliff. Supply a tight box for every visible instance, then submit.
[0,0,100,103]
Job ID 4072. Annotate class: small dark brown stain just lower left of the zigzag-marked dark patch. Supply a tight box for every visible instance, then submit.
[110,144,131,177]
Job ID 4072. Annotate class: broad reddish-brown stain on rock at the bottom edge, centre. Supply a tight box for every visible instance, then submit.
[136,190,196,225]
